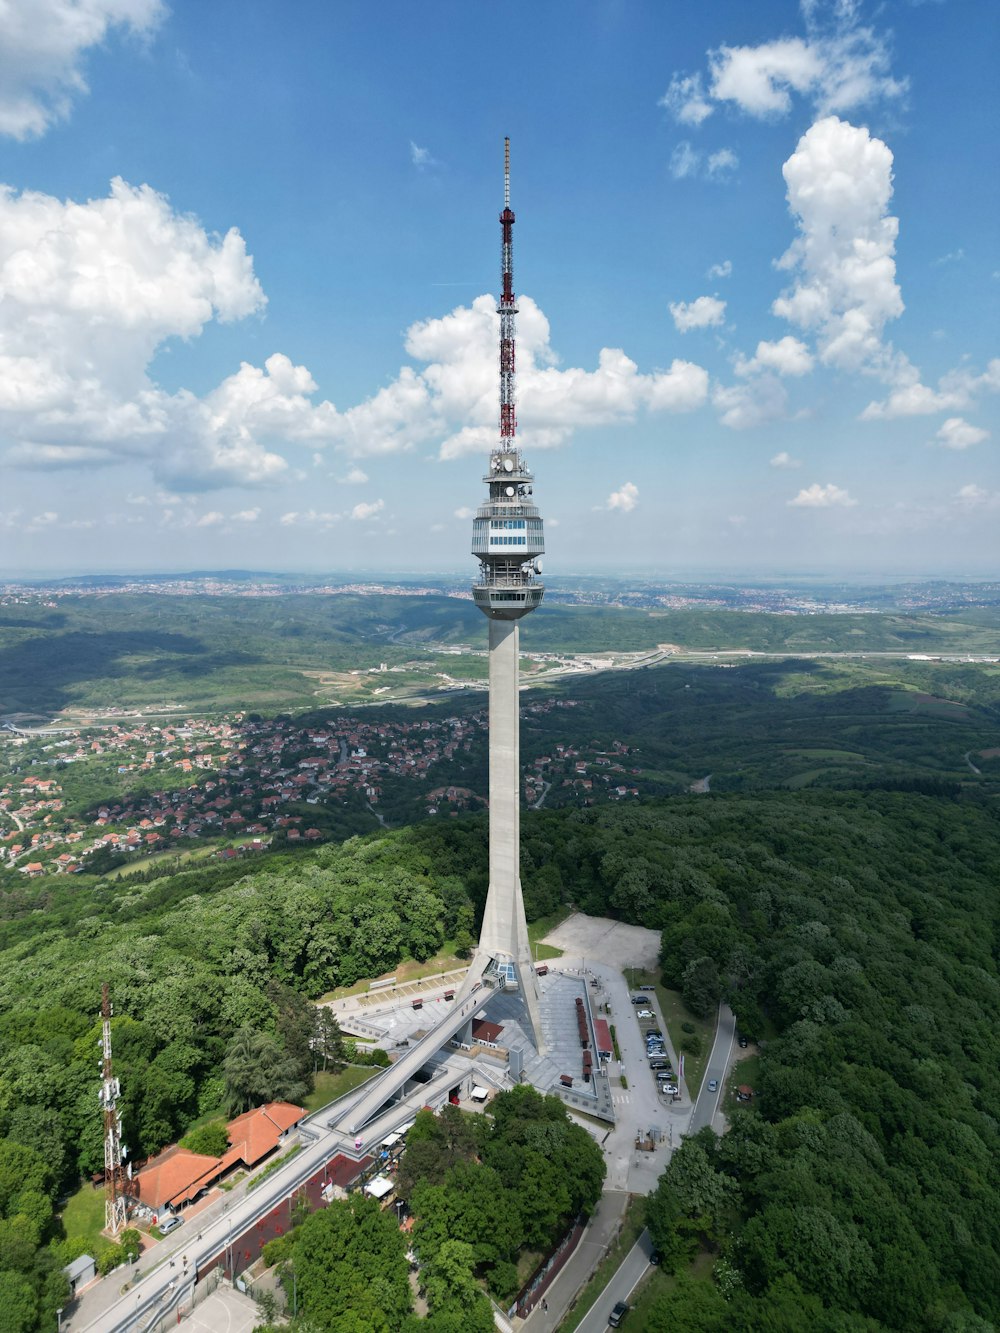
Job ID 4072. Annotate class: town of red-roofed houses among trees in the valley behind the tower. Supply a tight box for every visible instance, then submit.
[0,700,640,877]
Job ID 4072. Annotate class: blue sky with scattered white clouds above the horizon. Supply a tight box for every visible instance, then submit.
[0,0,1000,579]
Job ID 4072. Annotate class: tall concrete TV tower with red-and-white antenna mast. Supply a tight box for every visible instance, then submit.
[469,139,545,1050]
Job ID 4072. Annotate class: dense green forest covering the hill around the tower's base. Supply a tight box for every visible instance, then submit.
[0,789,1000,1330]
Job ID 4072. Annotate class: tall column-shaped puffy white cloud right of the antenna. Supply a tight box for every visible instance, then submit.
[772,116,903,375]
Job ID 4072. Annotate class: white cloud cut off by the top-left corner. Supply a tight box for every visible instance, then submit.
[0,0,167,140]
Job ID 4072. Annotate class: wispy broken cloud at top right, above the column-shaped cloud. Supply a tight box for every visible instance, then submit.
[660,0,907,125]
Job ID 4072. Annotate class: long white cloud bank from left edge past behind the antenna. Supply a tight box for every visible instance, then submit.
[0,180,708,493]
